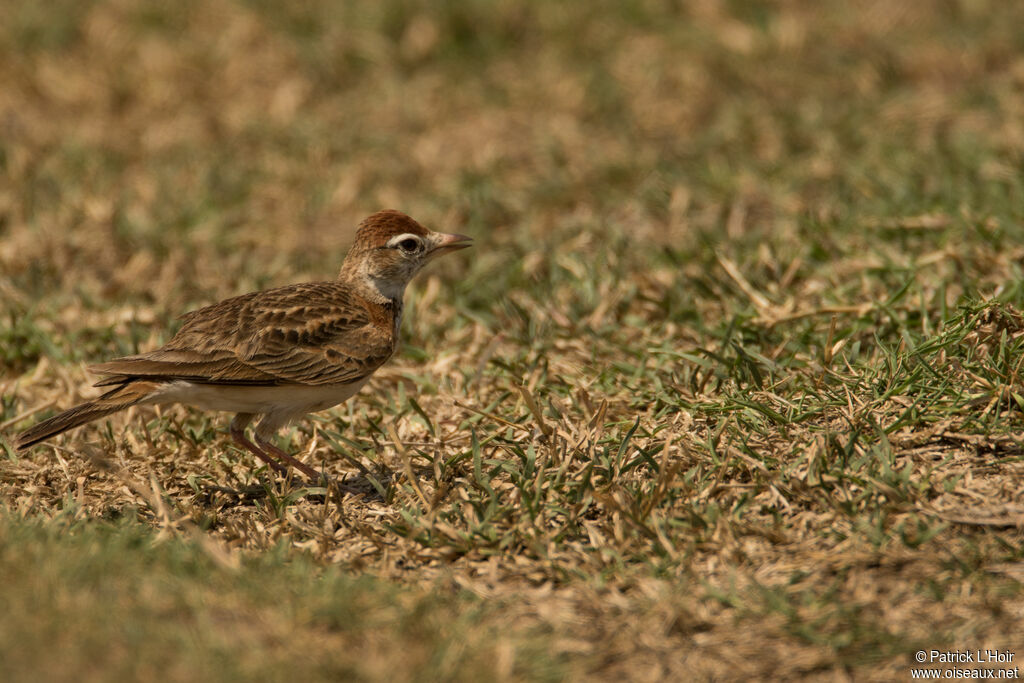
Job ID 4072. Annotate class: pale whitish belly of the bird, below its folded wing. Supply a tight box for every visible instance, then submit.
[145,377,370,431]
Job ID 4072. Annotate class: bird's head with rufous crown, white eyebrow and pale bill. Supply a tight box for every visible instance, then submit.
[339,210,472,300]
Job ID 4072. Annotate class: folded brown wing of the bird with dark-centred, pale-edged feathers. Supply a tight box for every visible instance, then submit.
[91,283,395,386]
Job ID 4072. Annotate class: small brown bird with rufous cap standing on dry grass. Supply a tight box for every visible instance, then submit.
[12,209,472,481]
